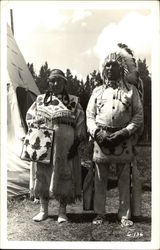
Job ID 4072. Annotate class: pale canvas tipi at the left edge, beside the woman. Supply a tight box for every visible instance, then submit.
[7,26,40,197]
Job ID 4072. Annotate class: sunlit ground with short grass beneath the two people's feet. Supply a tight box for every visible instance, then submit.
[7,188,151,241]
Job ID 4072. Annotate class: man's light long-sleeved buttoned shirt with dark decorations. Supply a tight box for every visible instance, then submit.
[86,81,143,137]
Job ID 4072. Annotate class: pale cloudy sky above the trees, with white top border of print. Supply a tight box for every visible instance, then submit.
[3,1,159,80]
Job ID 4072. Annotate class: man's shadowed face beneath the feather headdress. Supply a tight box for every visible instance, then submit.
[104,62,120,81]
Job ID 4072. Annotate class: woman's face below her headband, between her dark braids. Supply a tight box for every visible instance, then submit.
[49,77,65,94]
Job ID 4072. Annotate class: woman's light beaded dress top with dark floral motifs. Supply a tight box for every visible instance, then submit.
[26,94,86,139]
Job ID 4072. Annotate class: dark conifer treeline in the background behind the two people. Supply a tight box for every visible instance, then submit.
[27,59,151,145]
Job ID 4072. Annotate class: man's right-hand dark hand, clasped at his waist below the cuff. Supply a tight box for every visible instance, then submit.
[110,128,129,146]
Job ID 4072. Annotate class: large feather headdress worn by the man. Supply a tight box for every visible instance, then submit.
[103,43,137,81]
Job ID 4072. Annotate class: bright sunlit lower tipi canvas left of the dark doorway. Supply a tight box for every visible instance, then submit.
[7,82,29,196]
